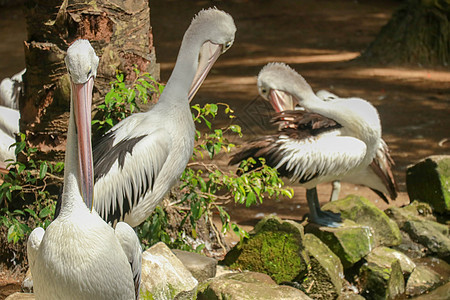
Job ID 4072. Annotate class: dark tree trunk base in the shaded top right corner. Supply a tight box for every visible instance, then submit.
[360,0,450,66]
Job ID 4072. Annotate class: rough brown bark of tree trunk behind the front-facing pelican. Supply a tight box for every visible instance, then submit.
[20,0,159,161]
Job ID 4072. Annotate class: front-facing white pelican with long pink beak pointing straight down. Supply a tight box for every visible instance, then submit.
[27,40,142,300]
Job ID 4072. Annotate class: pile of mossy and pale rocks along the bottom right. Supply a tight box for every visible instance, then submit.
[7,156,450,300]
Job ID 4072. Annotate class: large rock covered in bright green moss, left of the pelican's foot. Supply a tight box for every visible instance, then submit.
[221,217,308,283]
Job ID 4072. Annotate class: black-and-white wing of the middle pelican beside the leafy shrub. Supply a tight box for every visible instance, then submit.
[93,128,171,225]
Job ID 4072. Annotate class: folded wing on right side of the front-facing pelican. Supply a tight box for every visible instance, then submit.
[115,222,142,299]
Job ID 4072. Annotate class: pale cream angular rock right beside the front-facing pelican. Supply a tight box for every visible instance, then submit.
[141,242,198,299]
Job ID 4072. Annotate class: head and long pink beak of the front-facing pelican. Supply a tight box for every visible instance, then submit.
[65,40,99,209]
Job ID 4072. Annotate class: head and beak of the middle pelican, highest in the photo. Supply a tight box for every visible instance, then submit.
[185,8,236,101]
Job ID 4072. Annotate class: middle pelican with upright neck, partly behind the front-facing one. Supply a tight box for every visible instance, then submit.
[93,9,236,227]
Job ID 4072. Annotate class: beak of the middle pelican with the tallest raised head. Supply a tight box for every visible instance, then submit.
[188,42,222,102]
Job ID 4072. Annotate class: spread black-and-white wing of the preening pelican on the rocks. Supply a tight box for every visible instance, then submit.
[230,134,366,183]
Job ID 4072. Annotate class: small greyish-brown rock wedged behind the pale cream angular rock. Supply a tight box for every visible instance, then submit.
[172,249,217,283]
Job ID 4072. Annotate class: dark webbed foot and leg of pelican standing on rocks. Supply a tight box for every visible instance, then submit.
[306,188,342,227]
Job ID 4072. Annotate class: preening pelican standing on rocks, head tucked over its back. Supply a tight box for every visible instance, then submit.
[230,63,396,227]
